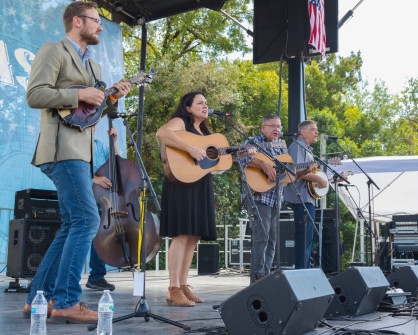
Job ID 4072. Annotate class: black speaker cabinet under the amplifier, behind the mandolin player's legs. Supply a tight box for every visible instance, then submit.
[6,219,61,278]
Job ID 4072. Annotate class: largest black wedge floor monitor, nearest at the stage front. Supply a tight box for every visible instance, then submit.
[219,269,334,335]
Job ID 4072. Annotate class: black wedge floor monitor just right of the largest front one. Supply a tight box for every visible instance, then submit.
[326,266,389,317]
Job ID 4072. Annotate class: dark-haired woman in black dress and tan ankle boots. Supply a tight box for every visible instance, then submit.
[157,91,216,306]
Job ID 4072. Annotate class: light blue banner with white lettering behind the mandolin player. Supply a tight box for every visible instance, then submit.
[0,0,126,262]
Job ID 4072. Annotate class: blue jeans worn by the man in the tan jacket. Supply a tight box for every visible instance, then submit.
[26,160,100,309]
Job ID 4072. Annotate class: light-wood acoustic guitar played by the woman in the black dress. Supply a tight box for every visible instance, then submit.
[160,131,286,183]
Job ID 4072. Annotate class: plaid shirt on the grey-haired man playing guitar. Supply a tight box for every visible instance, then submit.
[240,133,287,208]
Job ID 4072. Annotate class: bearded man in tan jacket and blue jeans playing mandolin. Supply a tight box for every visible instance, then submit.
[24,1,130,323]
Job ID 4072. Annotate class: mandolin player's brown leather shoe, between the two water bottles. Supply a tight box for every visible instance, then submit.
[51,302,98,323]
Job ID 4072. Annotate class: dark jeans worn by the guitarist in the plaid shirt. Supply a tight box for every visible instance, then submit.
[250,201,277,279]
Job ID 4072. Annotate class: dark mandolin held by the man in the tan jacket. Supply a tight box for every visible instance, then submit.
[57,69,157,131]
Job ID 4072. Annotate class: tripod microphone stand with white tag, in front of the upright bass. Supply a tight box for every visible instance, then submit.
[88,116,191,330]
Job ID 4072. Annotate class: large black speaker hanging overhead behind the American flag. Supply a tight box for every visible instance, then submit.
[253,0,338,64]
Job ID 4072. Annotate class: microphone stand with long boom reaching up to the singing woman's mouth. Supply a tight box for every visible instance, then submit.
[217,115,296,270]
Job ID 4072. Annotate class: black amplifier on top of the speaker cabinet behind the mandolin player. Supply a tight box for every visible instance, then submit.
[14,188,61,220]
